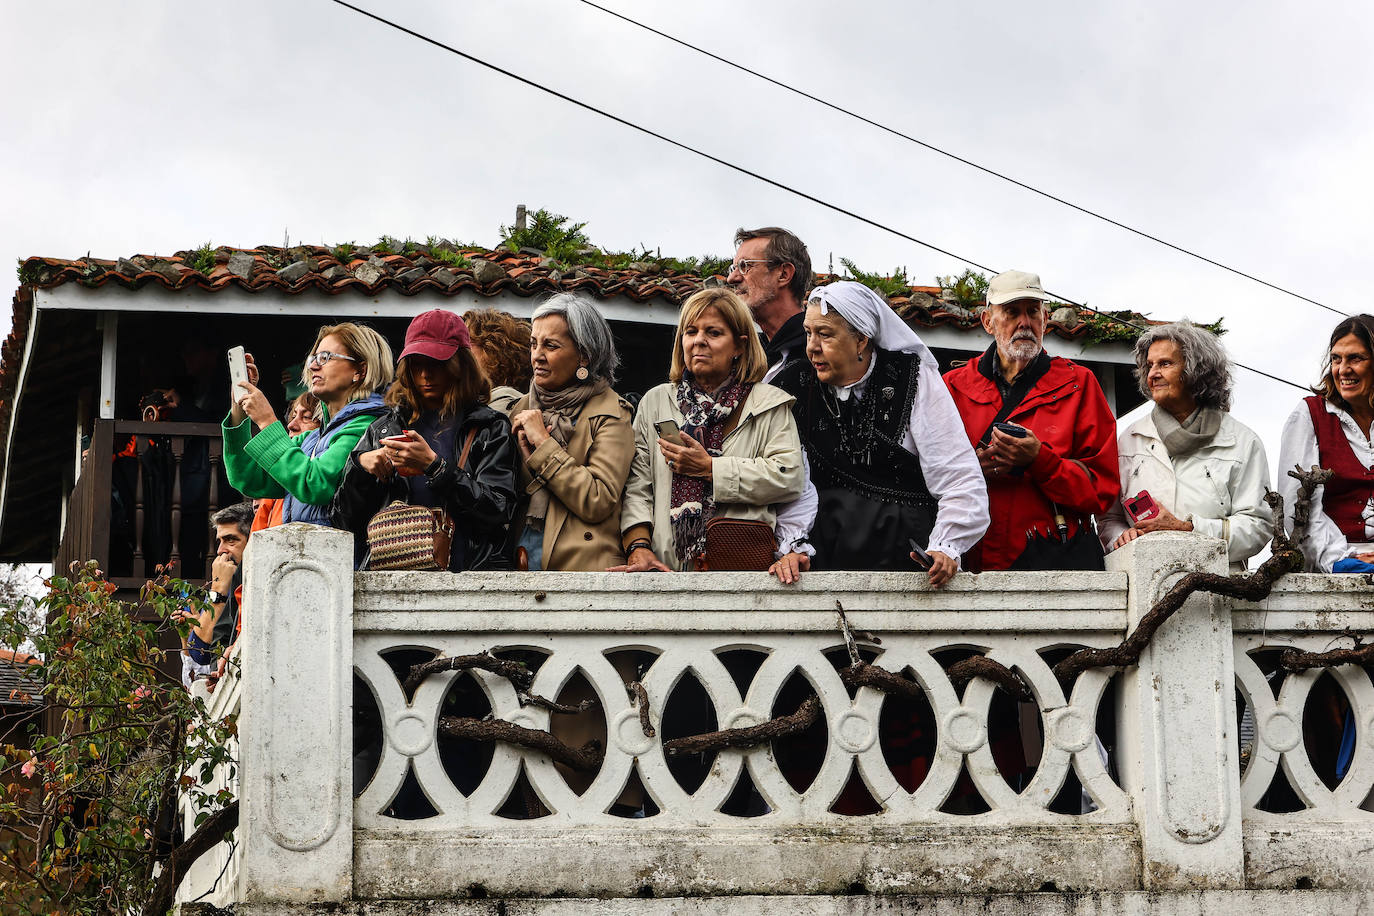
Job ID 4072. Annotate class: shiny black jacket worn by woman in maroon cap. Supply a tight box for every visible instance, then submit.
[330,405,519,573]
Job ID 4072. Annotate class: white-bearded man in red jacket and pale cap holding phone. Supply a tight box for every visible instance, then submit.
[944,271,1121,570]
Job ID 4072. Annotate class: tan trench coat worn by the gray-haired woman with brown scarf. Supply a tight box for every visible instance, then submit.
[511,389,635,573]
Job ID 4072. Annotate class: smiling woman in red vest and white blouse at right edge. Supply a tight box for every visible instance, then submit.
[1279,314,1374,573]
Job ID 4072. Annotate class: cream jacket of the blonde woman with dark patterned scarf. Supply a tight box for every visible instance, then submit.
[620,383,805,570]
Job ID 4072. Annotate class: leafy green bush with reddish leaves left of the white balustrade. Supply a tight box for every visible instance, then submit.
[0,562,238,916]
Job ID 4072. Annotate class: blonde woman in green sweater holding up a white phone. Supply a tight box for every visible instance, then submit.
[224,323,394,526]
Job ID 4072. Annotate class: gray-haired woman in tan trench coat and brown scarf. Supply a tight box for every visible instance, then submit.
[511,293,635,571]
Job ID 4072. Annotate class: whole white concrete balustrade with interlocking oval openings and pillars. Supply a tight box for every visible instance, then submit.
[181,526,1374,912]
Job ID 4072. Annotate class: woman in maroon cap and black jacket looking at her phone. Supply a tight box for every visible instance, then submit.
[330,315,518,573]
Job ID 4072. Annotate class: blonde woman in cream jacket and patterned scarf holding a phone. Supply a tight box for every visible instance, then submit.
[611,288,804,573]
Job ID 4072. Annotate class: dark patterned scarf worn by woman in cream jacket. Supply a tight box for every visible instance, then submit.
[668,374,754,566]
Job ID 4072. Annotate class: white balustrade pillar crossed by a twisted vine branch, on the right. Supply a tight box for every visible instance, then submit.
[1107,531,1245,890]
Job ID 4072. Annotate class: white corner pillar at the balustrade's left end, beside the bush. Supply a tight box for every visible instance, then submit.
[236,525,353,904]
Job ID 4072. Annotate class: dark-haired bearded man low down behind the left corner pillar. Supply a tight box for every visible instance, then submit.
[176,503,254,687]
